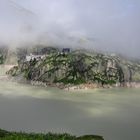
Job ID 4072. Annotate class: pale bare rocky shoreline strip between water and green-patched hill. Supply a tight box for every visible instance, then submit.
[0,72,140,91]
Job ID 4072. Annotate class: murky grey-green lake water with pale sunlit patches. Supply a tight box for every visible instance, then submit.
[0,67,140,140]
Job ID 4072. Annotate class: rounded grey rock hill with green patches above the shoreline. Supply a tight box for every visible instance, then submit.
[8,48,140,88]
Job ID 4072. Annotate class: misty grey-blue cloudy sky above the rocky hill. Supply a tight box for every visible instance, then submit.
[0,0,140,58]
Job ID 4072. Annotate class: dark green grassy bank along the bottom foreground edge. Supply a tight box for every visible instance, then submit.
[0,130,103,140]
